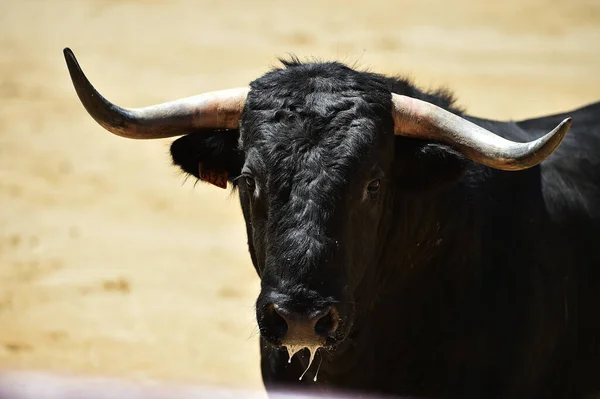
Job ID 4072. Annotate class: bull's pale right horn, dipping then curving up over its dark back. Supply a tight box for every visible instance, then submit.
[392,93,571,170]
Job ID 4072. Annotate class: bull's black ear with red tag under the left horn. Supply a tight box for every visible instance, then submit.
[171,130,244,188]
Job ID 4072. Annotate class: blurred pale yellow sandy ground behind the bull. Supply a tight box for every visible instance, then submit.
[0,0,600,389]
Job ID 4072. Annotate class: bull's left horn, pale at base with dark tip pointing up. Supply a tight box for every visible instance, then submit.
[64,48,249,139]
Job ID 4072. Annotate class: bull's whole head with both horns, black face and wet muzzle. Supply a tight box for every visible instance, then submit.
[65,49,570,358]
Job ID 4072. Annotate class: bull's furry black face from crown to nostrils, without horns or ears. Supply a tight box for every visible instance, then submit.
[238,59,394,346]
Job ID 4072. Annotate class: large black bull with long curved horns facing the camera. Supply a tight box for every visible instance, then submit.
[65,50,600,399]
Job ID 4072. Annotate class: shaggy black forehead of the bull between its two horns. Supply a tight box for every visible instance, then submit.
[241,62,392,173]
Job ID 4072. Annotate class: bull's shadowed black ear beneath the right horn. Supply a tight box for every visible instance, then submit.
[395,137,468,191]
